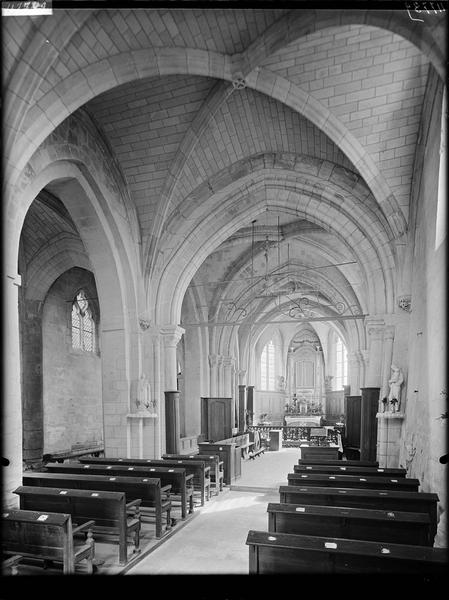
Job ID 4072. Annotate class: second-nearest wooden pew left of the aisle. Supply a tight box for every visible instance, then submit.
[14,485,141,565]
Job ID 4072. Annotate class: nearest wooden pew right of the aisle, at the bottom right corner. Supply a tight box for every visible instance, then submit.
[246,530,448,576]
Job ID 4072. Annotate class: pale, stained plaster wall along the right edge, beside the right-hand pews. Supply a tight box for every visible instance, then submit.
[400,67,447,545]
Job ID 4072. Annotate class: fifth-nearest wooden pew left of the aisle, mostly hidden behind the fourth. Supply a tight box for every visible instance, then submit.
[80,458,210,506]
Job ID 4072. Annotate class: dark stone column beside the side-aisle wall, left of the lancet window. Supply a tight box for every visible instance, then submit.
[21,300,44,464]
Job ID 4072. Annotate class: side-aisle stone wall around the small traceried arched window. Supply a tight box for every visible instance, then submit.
[42,269,104,453]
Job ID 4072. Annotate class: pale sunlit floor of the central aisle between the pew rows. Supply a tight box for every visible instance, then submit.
[125,448,299,575]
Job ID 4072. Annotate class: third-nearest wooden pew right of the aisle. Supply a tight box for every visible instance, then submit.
[279,485,438,536]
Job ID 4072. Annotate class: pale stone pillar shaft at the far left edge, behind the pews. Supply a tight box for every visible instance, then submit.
[2,273,22,508]
